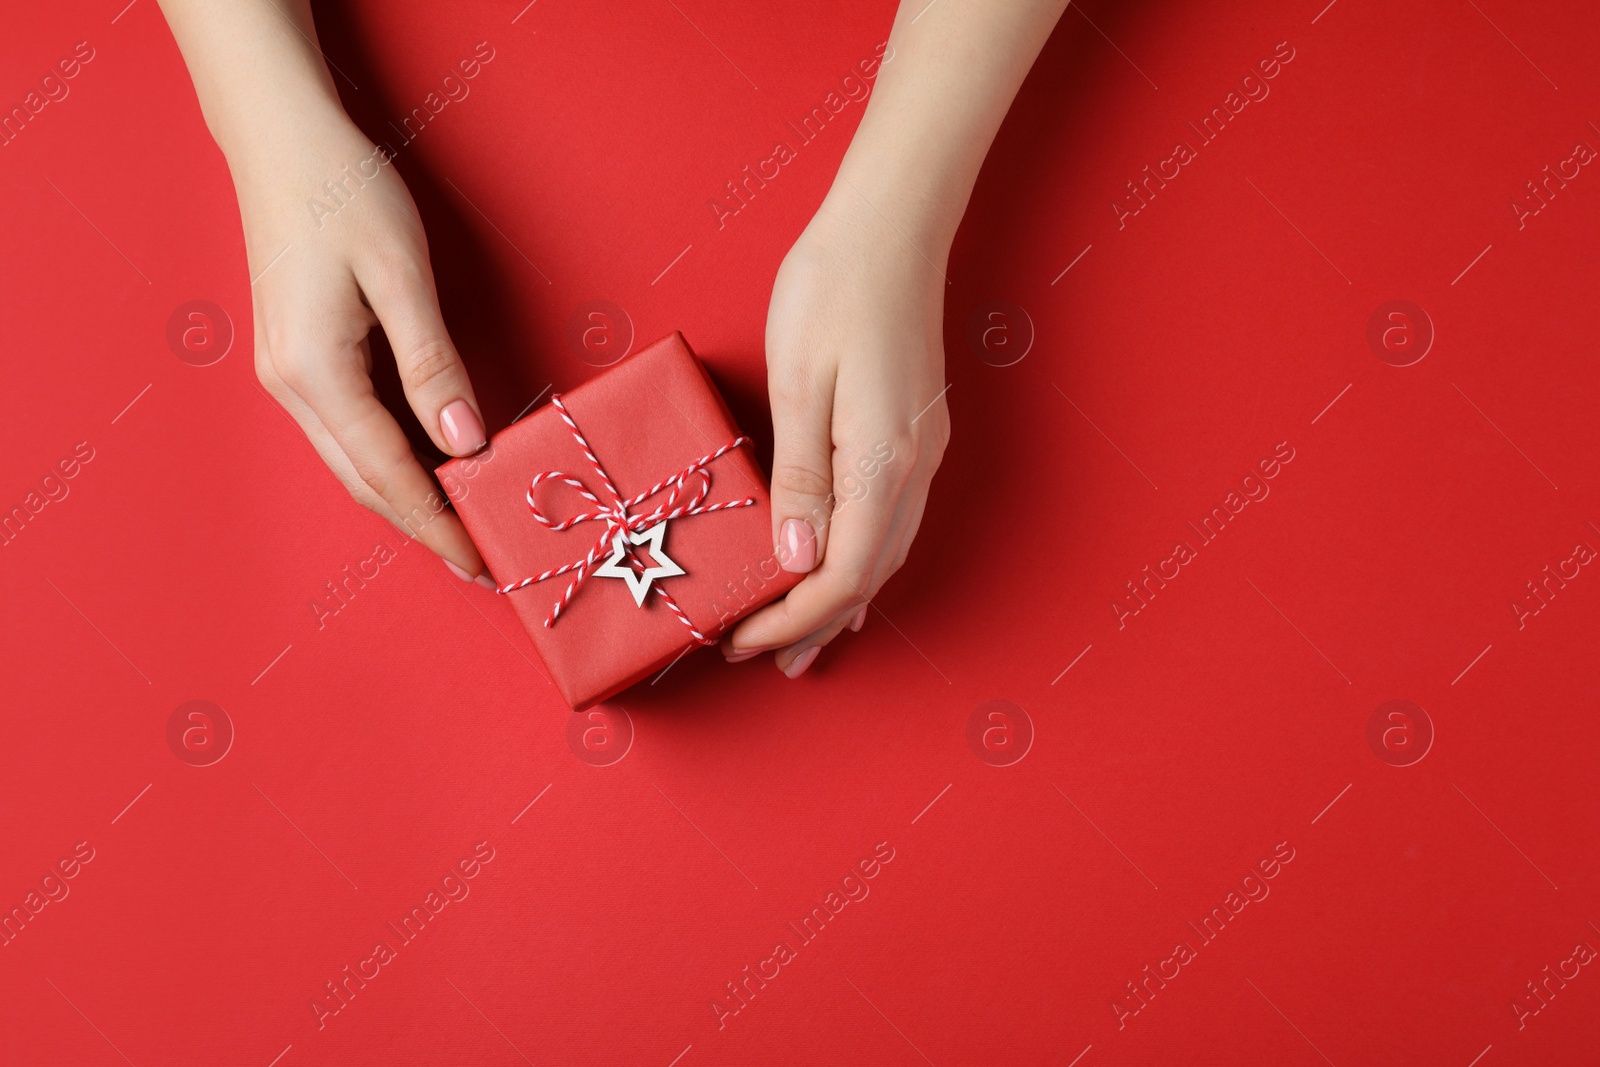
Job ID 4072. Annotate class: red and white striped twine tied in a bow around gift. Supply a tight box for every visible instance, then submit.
[494,394,755,645]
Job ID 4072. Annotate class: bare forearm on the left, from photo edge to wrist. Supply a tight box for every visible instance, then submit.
[160,0,342,181]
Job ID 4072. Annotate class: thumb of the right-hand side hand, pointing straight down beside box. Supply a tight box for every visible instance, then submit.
[771,375,834,574]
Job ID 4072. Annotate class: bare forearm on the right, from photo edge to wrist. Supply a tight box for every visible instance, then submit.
[829,0,1067,259]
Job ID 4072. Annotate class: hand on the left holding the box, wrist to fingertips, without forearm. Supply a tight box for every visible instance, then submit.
[229,101,493,587]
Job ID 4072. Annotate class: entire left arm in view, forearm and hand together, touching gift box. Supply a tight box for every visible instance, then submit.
[160,0,493,587]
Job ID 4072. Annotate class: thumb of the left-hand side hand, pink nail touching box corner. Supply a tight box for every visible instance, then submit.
[360,259,486,456]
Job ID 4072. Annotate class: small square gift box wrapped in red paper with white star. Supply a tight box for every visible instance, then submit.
[438,333,802,710]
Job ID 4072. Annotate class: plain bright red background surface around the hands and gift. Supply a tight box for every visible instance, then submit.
[0,0,1600,1067]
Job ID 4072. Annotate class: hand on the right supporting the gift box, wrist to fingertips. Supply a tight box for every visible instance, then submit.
[723,189,950,678]
